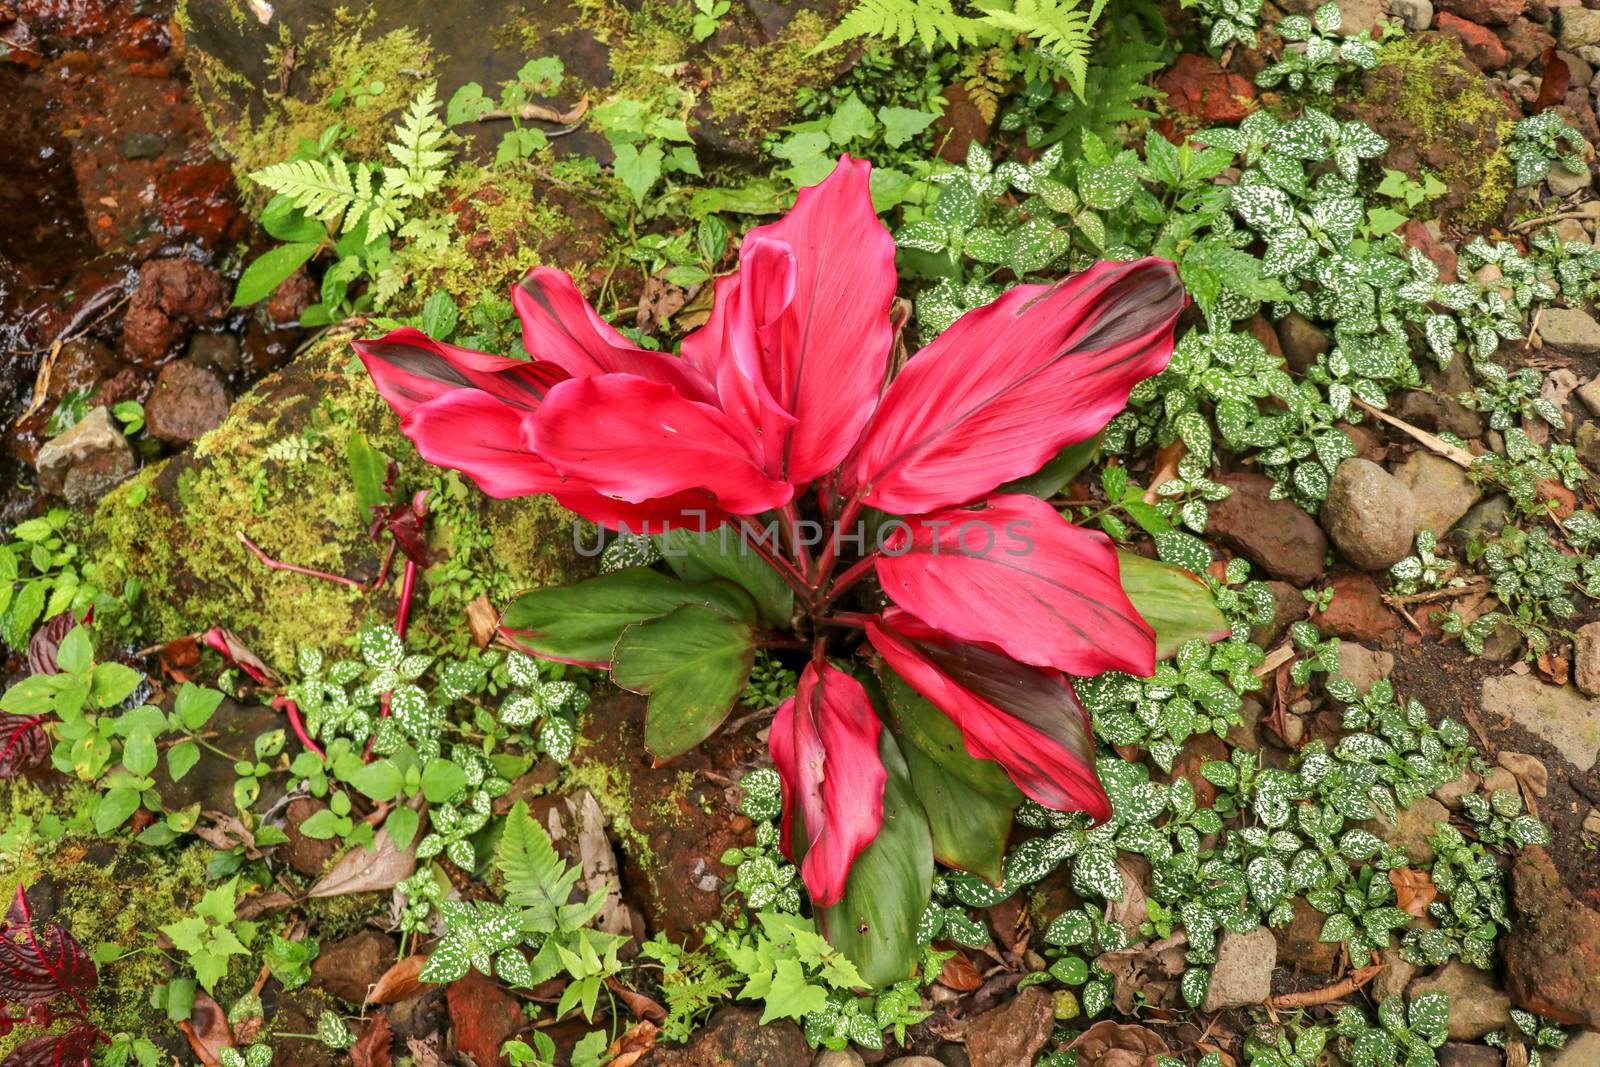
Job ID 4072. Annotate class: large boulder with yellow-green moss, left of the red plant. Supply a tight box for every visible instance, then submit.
[88,326,589,667]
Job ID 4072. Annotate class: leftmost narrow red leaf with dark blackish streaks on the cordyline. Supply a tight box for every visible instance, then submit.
[350,328,568,419]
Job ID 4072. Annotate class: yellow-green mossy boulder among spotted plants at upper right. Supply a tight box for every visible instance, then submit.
[1341,34,1520,226]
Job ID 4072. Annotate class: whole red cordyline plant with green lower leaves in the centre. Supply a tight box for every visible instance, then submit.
[355,157,1187,979]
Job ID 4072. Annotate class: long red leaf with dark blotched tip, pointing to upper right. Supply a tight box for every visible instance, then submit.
[845,259,1187,515]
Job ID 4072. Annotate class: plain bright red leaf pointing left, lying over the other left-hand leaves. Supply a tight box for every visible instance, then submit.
[531,374,794,515]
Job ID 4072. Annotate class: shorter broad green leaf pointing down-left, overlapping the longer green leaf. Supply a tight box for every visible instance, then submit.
[611,605,755,760]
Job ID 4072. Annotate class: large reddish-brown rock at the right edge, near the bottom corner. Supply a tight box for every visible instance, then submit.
[1501,845,1600,1029]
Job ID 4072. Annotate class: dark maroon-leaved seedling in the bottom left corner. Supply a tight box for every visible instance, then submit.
[0,886,109,1067]
